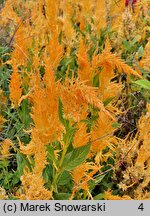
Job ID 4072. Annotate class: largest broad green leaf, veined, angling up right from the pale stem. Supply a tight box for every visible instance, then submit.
[63,144,91,170]
